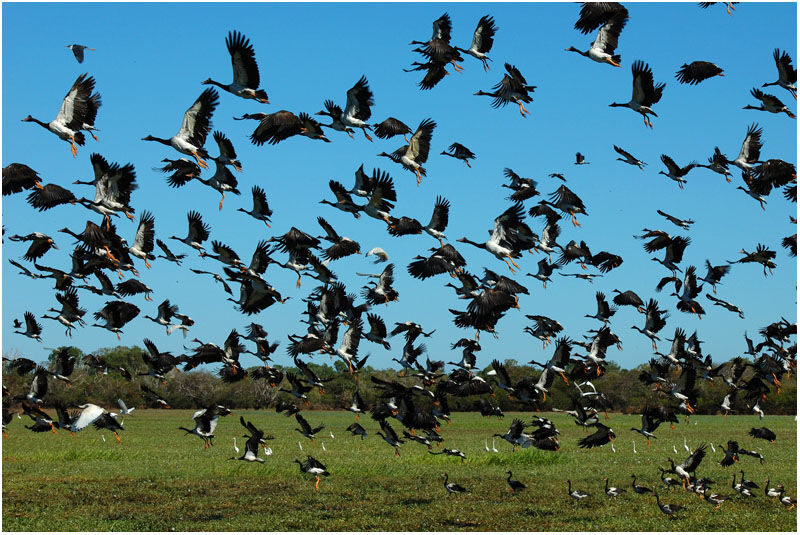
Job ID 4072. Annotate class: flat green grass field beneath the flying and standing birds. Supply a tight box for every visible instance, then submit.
[2,409,797,531]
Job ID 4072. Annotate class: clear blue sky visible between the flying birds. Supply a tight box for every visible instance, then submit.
[2,3,797,367]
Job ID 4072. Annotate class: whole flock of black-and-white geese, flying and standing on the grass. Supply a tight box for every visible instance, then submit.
[3,2,797,515]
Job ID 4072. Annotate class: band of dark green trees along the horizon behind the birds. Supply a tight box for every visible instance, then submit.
[3,346,797,415]
